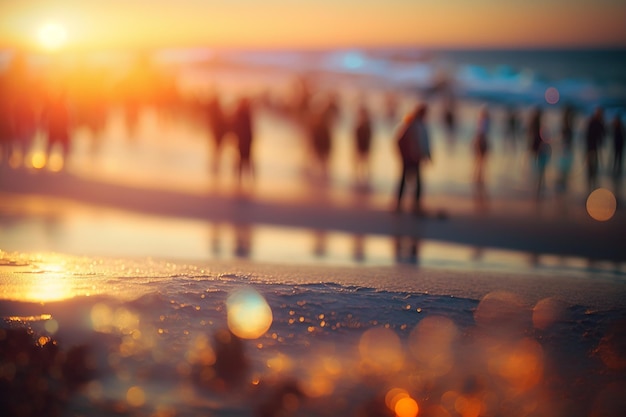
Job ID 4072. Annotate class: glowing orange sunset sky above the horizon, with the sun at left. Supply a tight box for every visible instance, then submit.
[0,0,626,50]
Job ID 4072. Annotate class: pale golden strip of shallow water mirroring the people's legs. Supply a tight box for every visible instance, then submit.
[0,191,624,272]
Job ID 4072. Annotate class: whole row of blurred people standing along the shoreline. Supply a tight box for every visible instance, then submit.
[0,53,624,213]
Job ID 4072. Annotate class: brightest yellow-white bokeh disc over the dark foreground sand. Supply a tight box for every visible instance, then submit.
[226,288,273,339]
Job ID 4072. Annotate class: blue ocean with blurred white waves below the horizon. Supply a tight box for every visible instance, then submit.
[159,48,626,115]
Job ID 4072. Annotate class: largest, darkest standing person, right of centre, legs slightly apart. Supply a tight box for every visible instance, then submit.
[396,104,431,216]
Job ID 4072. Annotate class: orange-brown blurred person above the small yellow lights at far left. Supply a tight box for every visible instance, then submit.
[43,88,71,165]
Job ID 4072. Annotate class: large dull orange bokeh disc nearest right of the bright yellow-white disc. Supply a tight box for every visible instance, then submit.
[359,327,404,373]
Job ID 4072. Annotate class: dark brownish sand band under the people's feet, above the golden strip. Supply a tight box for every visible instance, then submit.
[0,163,626,267]
